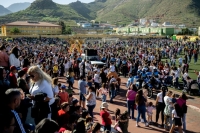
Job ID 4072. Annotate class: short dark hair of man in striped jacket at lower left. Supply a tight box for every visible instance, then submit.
[5,89,21,104]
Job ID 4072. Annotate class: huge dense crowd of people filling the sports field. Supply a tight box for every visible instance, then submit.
[0,38,200,133]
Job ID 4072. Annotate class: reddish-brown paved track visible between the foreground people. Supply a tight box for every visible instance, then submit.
[59,78,200,133]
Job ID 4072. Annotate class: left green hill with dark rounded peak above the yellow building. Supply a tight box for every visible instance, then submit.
[0,0,85,23]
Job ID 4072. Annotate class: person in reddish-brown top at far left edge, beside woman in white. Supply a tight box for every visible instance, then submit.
[0,45,9,70]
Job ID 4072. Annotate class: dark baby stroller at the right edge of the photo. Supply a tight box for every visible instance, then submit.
[186,80,199,95]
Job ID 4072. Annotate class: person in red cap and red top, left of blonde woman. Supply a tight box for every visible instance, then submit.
[9,66,18,88]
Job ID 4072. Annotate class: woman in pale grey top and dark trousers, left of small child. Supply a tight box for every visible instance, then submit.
[85,87,96,118]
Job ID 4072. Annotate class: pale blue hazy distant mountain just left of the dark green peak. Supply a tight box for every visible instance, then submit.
[7,2,31,13]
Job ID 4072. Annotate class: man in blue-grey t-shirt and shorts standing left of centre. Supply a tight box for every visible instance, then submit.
[78,76,88,109]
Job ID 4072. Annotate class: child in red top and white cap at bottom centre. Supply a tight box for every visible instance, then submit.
[100,102,112,131]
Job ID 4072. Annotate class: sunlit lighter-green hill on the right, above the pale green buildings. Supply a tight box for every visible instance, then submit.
[97,0,200,25]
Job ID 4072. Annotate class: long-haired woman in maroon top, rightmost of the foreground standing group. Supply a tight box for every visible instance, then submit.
[176,93,188,132]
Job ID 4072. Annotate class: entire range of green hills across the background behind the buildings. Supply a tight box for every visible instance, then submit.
[0,0,200,27]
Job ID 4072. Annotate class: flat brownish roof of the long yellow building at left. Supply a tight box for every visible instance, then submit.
[5,21,60,27]
